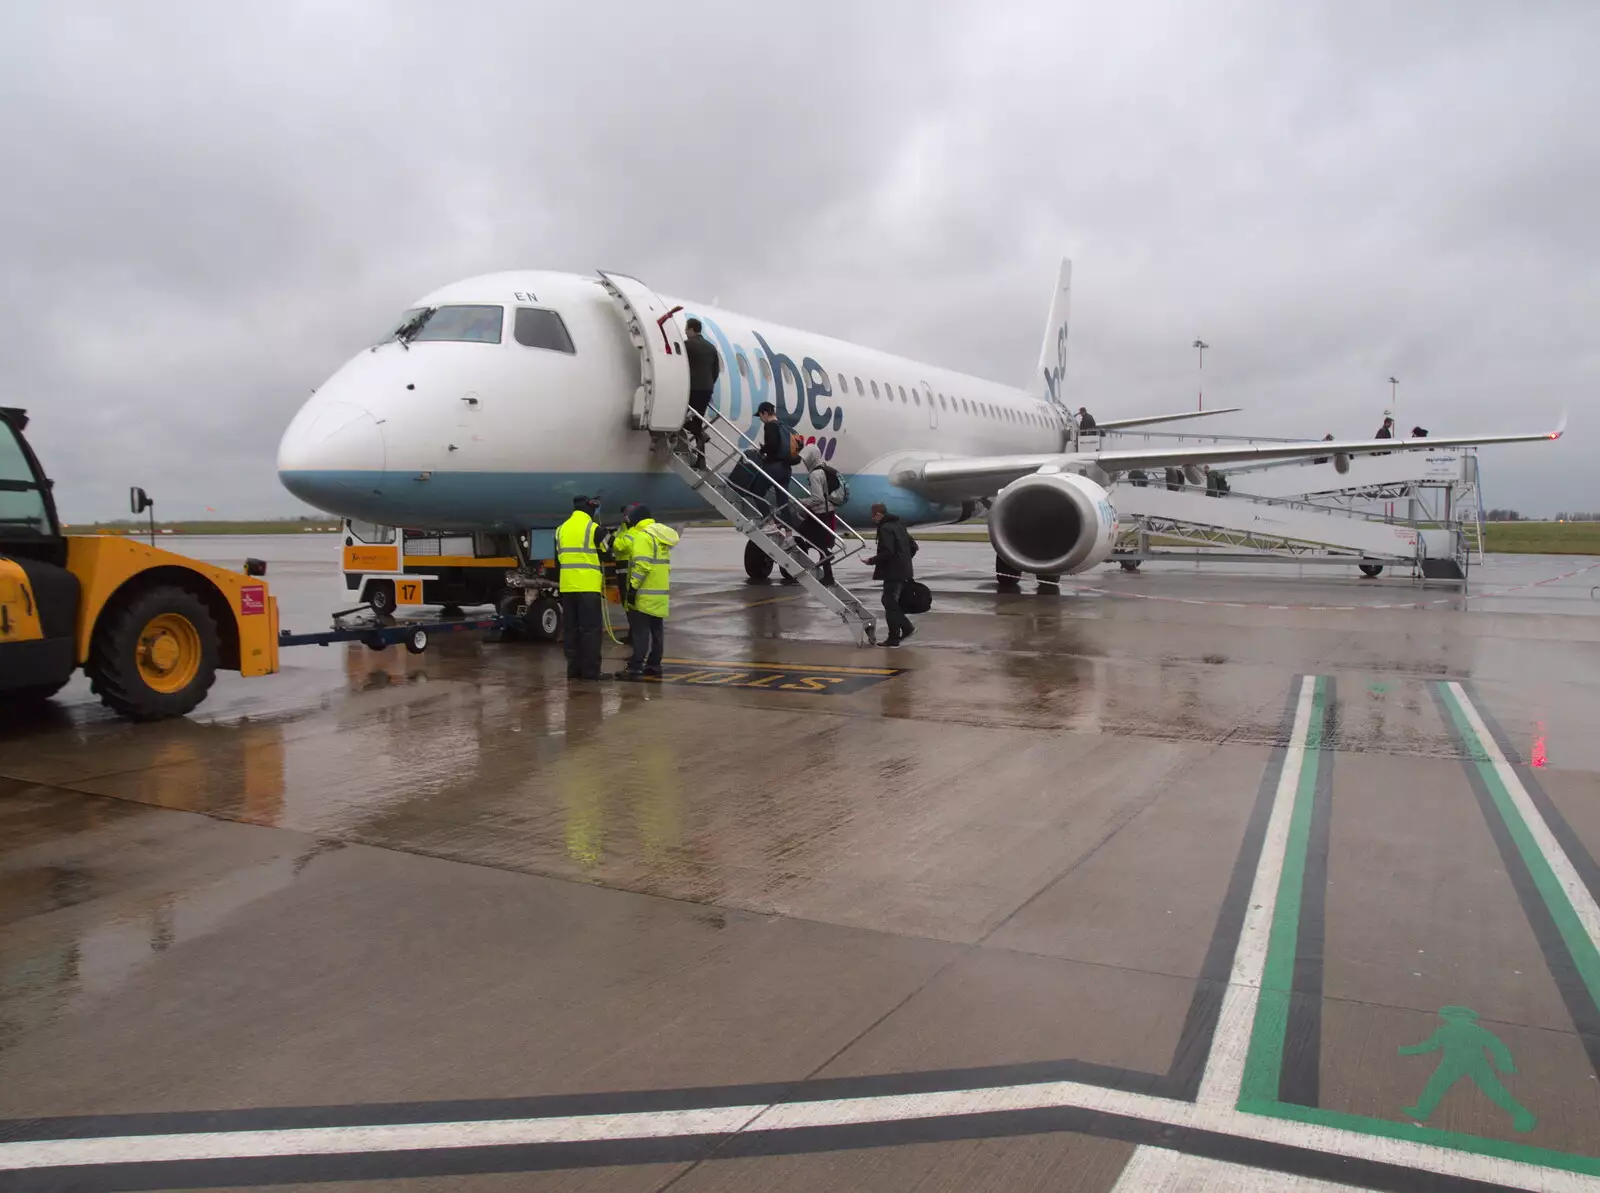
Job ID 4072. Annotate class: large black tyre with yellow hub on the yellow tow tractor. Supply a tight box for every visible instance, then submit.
[83,584,219,721]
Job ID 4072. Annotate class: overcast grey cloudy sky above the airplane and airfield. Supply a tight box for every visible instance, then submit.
[0,0,1600,520]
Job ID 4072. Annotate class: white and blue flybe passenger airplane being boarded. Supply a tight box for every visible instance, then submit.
[278,261,1565,591]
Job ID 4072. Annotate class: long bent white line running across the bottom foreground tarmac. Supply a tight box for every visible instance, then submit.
[0,1081,1600,1193]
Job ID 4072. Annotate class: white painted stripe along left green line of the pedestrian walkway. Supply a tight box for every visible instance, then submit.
[1198,675,1317,1107]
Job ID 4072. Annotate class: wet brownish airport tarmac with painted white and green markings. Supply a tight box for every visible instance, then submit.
[0,531,1600,1193]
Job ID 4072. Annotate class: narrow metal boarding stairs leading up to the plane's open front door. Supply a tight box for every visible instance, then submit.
[654,411,877,646]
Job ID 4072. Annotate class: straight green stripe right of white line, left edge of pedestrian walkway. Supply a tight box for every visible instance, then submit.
[1238,675,1328,1102]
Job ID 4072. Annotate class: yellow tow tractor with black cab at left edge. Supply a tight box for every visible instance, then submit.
[0,406,278,721]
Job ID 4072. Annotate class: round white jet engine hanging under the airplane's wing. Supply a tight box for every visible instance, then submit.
[989,472,1117,574]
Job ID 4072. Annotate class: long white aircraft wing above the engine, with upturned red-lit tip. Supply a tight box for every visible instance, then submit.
[894,416,1566,497]
